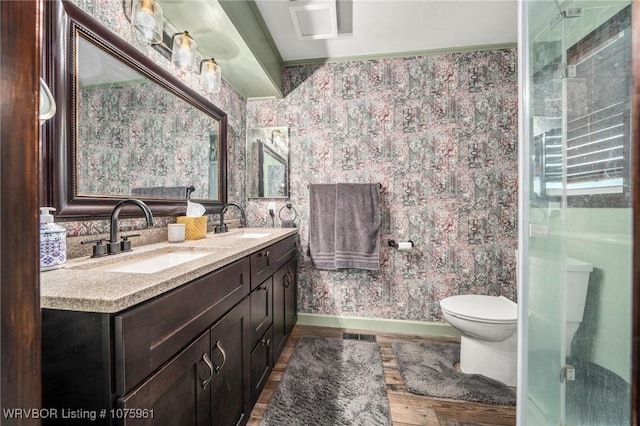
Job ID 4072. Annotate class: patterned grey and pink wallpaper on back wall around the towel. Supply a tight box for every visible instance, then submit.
[247,50,518,321]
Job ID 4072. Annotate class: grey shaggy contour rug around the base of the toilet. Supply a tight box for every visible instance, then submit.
[391,342,516,405]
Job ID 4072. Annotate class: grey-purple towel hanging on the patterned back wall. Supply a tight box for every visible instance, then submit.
[309,183,380,271]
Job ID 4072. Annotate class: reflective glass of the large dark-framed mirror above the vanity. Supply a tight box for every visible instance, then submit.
[75,32,220,200]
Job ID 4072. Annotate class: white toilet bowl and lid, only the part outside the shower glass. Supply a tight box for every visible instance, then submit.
[440,294,518,386]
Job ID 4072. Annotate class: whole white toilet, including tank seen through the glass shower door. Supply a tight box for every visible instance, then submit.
[440,256,593,386]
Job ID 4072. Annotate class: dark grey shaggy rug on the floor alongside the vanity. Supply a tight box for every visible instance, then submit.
[261,336,391,426]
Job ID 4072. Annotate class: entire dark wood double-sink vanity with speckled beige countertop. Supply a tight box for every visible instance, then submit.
[41,228,299,425]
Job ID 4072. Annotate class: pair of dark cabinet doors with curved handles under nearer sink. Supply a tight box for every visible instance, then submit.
[115,298,250,426]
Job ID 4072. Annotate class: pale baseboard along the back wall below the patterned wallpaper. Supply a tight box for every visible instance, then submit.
[297,313,460,337]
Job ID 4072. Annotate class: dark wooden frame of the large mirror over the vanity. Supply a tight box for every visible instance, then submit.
[40,0,227,218]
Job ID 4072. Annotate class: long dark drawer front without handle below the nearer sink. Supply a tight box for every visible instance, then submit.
[114,258,250,395]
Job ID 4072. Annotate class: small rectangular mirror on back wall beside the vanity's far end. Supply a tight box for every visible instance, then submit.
[247,127,289,198]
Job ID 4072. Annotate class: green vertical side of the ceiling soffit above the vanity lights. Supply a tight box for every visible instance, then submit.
[219,0,283,98]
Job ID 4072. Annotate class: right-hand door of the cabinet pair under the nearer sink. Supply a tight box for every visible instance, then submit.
[211,298,251,426]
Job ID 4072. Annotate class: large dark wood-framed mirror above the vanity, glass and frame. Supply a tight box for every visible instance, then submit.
[40,0,227,218]
